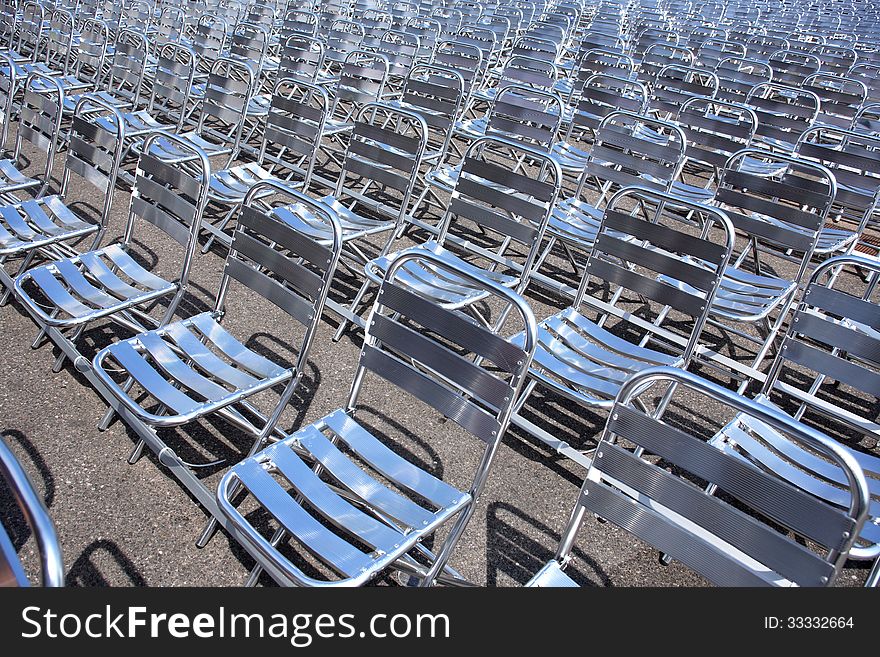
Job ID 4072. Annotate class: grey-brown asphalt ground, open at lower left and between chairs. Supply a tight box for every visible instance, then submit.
[0,110,876,586]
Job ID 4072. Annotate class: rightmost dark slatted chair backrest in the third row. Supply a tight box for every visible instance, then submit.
[715,148,837,281]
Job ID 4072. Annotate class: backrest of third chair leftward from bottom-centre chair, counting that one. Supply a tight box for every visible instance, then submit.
[123,131,211,294]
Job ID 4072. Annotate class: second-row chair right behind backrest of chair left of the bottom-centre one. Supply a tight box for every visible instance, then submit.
[273,103,428,336]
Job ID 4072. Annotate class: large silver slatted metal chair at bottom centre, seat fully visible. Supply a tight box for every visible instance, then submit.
[217,253,535,587]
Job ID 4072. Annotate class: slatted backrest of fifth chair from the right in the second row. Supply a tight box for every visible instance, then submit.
[259,78,330,189]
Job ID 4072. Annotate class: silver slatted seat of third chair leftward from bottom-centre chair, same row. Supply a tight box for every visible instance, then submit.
[15,244,177,327]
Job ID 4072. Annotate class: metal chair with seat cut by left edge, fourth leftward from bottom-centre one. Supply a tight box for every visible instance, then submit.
[0,95,124,303]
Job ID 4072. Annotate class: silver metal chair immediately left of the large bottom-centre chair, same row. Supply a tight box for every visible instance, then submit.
[92,181,342,547]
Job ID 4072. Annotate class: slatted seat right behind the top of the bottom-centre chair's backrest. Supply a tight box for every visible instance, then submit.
[365,240,519,308]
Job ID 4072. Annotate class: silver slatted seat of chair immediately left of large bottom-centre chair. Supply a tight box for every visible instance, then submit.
[94,313,292,426]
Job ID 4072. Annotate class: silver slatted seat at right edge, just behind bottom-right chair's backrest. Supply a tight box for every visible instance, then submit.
[710,395,880,544]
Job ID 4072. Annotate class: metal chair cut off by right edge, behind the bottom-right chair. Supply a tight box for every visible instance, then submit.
[712,255,880,587]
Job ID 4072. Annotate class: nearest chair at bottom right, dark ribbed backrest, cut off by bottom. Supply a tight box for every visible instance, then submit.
[527,367,870,587]
